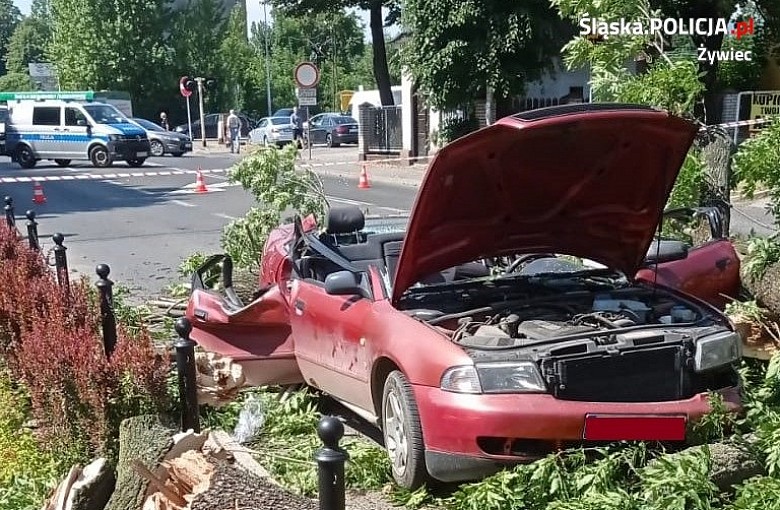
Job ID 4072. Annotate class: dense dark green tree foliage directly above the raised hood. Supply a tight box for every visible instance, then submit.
[403,0,570,108]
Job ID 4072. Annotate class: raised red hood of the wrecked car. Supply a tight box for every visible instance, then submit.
[392,103,697,302]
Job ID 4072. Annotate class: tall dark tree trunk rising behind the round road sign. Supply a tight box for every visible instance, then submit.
[272,0,400,106]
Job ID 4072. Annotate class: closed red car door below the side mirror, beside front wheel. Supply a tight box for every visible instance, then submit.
[290,266,373,407]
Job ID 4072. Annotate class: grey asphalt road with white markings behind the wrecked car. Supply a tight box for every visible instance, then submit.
[0,148,416,295]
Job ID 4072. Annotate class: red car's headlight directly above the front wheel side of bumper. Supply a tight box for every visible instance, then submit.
[441,361,547,393]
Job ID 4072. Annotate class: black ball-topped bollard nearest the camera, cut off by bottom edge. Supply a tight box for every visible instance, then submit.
[314,416,349,510]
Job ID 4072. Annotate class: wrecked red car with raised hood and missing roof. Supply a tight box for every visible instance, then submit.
[187,104,741,488]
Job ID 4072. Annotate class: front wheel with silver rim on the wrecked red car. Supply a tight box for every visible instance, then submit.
[381,370,429,490]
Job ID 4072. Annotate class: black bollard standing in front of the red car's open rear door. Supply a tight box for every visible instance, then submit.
[174,317,200,433]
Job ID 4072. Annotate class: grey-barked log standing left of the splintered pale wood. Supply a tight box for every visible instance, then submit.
[106,415,175,510]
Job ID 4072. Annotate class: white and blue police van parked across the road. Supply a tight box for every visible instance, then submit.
[5,92,151,168]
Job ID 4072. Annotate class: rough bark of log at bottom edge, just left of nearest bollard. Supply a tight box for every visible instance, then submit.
[190,462,319,510]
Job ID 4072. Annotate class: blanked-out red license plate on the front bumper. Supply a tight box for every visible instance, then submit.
[582,414,687,441]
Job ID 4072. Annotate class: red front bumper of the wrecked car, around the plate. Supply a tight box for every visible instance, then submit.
[414,386,741,482]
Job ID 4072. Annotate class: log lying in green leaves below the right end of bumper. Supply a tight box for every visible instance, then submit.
[650,443,764,492]
